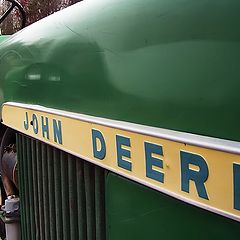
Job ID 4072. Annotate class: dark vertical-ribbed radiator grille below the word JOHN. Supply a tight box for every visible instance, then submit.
[17,134,106,240]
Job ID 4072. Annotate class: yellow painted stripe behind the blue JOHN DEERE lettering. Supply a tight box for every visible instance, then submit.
[2,104,240,221]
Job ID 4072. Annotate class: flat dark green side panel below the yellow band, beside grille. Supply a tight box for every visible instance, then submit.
[106,174,240,240]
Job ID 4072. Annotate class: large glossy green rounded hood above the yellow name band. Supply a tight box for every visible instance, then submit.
[0,0,240,140]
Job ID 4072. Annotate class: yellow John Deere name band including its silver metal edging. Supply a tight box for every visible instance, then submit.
[2,103,240,221]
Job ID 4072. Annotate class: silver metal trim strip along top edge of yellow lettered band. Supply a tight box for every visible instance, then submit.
[3,102,240,154]
